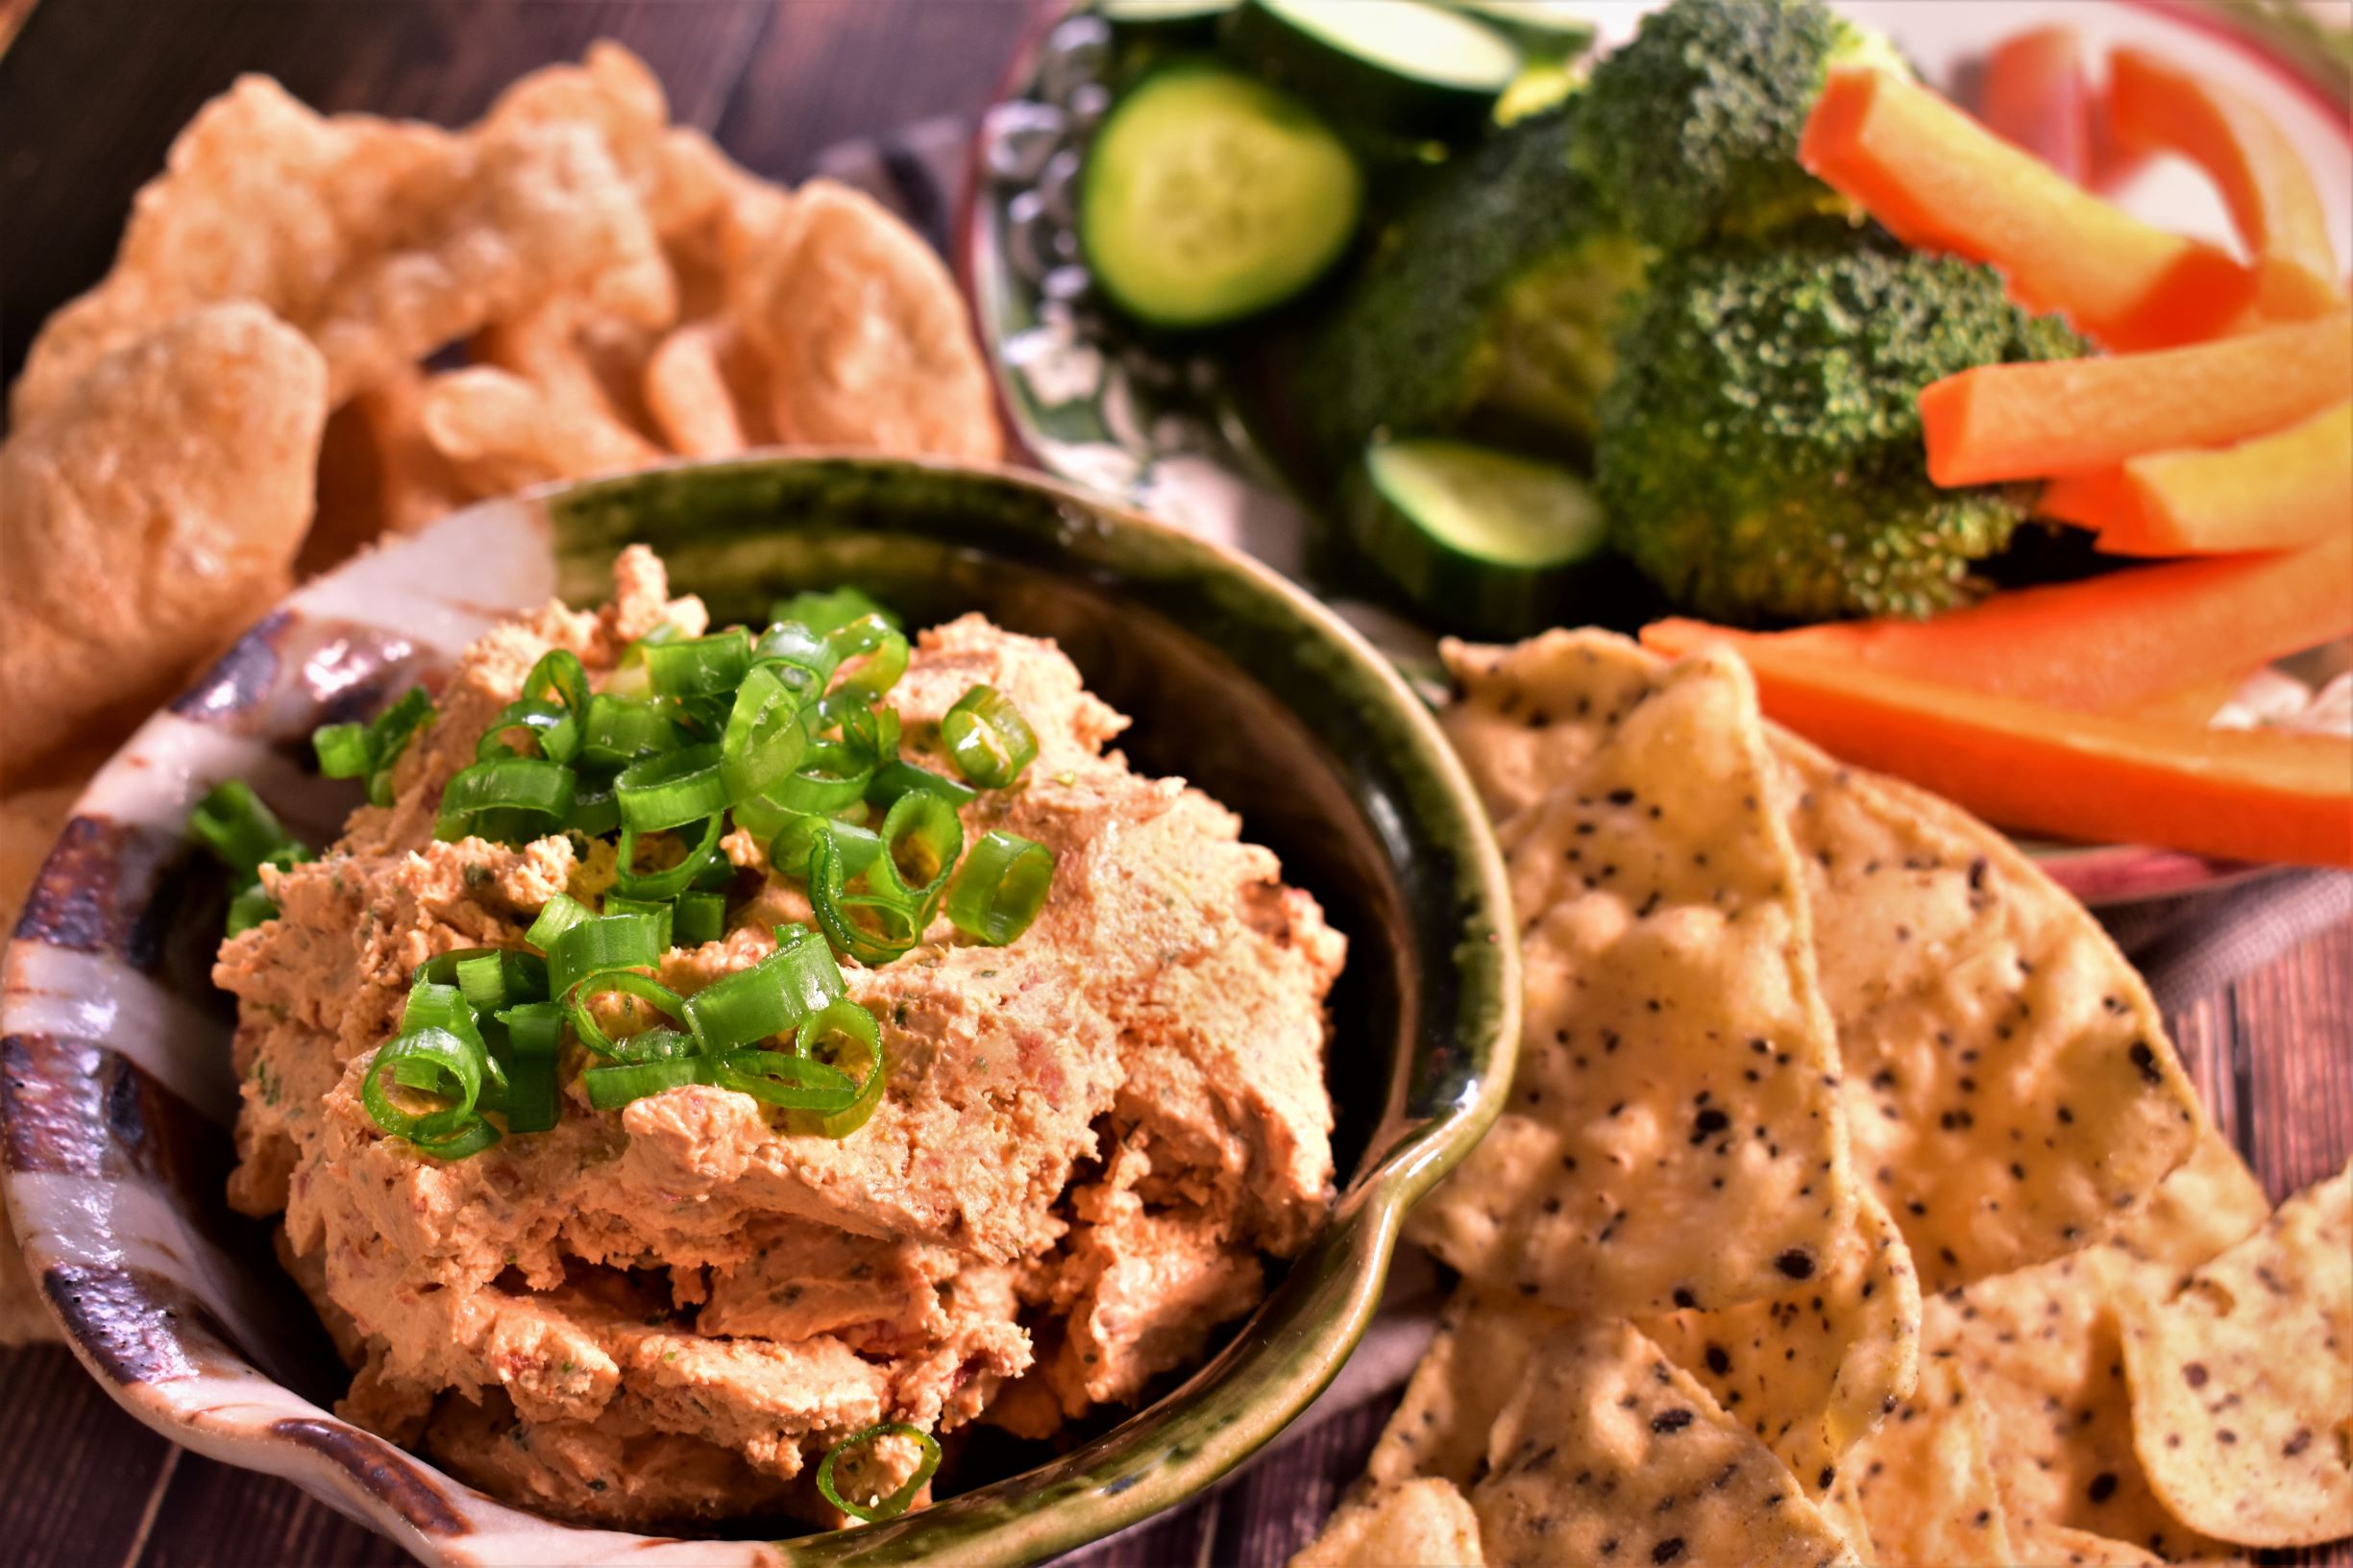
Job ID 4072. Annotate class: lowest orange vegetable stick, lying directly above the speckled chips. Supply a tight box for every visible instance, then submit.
[1703,645,2353,867]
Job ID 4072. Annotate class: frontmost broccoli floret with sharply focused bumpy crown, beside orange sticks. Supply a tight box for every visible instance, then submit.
[1598,219,2085,624]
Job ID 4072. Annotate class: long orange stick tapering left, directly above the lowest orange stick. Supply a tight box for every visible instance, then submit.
[1642,532,2353,713]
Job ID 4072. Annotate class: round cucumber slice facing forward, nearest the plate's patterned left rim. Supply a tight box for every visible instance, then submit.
[1078,61,1364,328]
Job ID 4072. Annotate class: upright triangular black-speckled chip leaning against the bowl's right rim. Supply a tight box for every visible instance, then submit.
[1409,652,1854,1313]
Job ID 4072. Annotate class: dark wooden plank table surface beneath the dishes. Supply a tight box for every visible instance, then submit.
[0,0,2353,1568]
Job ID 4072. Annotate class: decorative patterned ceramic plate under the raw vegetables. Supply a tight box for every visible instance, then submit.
[958,0,2353,904]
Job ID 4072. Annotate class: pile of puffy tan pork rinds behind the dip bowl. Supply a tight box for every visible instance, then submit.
[0,42,1000,1342]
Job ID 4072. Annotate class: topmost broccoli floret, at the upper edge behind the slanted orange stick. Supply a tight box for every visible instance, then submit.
[1572,0,1908,250]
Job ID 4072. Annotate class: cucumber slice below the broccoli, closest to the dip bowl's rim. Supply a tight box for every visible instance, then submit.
[1346,438,1614,636]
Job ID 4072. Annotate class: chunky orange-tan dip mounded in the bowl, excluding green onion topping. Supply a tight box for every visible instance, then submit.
[214,549,1346,1523]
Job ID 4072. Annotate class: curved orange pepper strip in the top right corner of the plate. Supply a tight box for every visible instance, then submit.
[2108,47,2343,320]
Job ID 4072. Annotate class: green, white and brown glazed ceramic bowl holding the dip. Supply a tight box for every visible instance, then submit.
[0,456,1520,1566]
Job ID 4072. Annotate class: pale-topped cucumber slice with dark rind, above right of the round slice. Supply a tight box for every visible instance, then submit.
[1226,0,1520,141]
